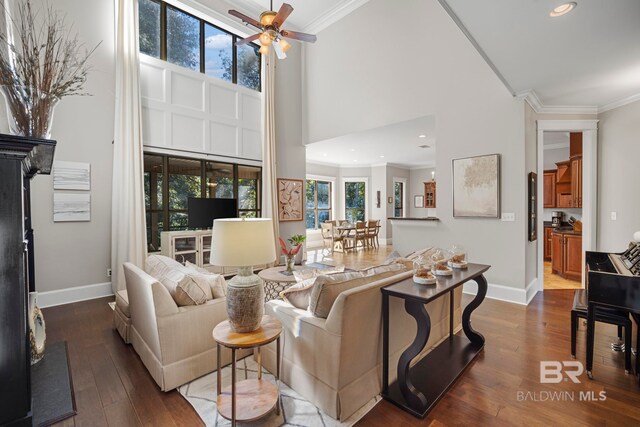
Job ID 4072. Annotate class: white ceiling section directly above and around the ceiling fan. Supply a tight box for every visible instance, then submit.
[222,0,368,33]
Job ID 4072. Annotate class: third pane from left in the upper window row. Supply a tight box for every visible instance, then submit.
[204,23,233,82]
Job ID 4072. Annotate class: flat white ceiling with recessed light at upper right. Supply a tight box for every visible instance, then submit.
[440,0,640,109]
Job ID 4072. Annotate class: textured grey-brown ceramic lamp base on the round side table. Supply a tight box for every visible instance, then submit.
[227,267,264,332]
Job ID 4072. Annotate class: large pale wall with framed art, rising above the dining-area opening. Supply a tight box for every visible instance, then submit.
[305,0,526,288]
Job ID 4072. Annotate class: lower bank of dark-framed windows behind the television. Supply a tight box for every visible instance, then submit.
[144,153,262,252]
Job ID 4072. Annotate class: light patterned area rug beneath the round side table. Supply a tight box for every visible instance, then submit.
[178,356,381,427]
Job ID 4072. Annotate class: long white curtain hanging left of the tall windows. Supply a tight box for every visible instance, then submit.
[111,0,147,292]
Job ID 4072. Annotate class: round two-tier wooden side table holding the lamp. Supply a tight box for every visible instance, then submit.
[213,315,282,426]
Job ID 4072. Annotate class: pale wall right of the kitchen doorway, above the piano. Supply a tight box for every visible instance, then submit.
[598,102,640,252]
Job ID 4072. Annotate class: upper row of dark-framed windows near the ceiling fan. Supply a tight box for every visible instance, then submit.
[139,0,262,91]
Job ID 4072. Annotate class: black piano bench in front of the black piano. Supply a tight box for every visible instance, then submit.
[571,289,632,373]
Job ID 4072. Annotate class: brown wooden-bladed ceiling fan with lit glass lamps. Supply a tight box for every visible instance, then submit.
[229,0,317,59]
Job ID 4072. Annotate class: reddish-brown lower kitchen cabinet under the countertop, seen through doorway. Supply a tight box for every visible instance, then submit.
[551,231,582,280]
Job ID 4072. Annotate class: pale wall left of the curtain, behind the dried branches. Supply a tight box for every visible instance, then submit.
[0,0,115,292]
